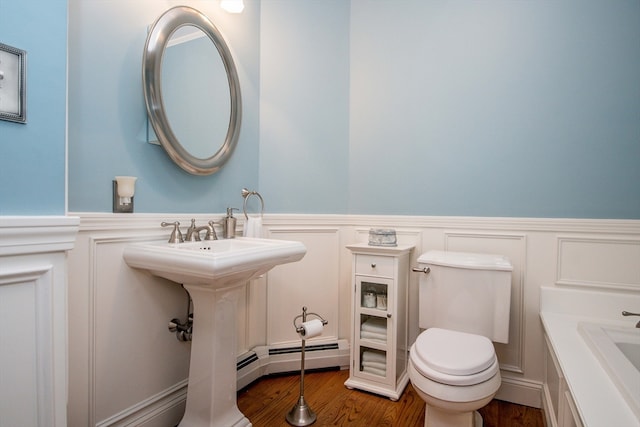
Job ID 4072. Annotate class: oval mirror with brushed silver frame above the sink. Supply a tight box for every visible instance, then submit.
[142,6,242,175]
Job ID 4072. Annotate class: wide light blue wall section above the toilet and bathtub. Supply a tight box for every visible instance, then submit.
[348,0,640,218]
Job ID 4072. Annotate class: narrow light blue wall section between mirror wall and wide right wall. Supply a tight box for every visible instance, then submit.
[260,0,349,213]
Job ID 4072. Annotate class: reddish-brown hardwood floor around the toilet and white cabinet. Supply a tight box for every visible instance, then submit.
[238,371,544,427]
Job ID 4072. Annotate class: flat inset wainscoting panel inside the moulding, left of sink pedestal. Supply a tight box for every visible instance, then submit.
[89,237,190,423]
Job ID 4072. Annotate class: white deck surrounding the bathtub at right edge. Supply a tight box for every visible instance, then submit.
[540,287,640,427]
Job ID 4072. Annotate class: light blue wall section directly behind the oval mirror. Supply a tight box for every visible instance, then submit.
[69,0,260,213]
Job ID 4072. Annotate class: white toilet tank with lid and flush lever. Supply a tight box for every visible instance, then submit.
[418,251,513,344]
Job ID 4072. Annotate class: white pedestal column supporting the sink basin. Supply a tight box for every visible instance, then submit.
[179,282,251,427]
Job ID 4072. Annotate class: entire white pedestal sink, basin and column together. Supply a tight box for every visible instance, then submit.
[123,238,306,427]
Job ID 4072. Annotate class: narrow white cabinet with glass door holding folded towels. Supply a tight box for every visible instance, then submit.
[345,244,413,400]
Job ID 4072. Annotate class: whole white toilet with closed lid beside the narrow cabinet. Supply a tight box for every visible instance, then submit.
[408,251,513,427]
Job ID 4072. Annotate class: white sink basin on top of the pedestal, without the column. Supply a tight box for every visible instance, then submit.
[124,237,306,288]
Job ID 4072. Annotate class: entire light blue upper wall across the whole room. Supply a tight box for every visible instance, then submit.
[6,0,640,219]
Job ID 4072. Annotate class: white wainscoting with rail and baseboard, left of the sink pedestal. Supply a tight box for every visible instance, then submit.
[69,230,191,426]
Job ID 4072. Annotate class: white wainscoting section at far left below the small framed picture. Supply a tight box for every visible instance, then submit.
[0,217,79,427]
